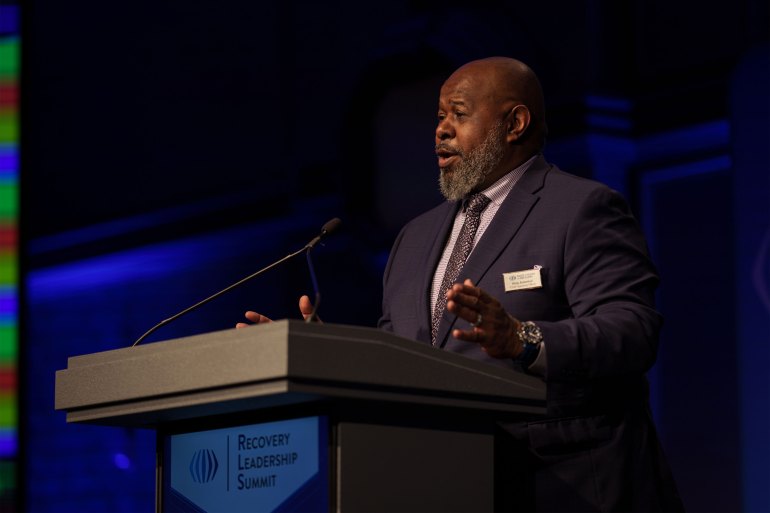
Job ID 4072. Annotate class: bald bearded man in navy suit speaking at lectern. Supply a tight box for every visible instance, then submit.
[239,57,683,511]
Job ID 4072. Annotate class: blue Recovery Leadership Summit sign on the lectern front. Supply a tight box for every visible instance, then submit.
[161,416,329,513]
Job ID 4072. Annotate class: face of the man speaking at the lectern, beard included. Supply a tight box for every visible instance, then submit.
[436,72,507,200]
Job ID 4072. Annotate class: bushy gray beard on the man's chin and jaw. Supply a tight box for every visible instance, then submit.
[438,122,506,201]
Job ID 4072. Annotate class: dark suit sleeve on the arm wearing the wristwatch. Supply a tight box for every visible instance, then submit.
[533,187,663,382]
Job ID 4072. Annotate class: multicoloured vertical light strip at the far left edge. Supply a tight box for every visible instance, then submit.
[0,2,20,511]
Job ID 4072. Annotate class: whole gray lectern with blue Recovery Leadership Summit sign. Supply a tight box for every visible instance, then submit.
[55,320,545,512]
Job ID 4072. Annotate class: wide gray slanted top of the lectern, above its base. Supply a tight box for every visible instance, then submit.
[56,320,545,423]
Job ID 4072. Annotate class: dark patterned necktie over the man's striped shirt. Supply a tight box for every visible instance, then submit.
[431,193,489,346]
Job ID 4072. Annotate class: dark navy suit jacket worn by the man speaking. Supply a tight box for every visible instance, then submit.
[379,156,682,511]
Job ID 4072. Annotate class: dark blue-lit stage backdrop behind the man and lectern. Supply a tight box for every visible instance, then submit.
[18,0,770,512]
